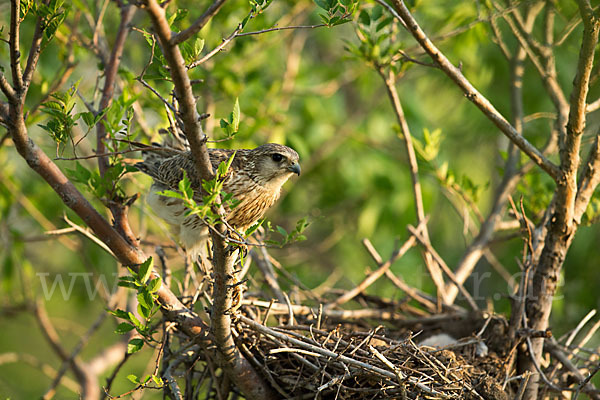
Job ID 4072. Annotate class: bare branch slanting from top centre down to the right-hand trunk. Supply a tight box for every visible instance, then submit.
[386,0,560,181]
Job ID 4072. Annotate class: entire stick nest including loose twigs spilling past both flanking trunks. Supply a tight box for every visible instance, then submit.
[165,247,600,400]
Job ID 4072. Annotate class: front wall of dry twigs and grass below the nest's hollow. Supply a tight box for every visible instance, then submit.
[236,302,508,400]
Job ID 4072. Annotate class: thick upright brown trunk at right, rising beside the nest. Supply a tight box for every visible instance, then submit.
[520,0,600,400]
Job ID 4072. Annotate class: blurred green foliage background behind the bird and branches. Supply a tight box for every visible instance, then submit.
[0,0,600,399]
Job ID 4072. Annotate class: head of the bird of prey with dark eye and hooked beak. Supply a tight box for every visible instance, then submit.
[249,143,300,186]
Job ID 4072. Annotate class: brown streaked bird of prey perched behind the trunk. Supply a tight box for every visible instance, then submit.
[136,143,300,259]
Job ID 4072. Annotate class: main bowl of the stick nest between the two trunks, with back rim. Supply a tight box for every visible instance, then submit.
[230,299,509,400]
